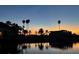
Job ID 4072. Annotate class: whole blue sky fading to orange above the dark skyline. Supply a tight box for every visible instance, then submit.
[0,5,79,34]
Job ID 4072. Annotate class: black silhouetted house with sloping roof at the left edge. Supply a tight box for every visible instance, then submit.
[0,22,15,38]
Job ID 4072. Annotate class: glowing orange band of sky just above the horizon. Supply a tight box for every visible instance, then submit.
[25,24,79,34]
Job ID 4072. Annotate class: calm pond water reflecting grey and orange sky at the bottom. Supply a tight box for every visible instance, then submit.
[19,43,79,54]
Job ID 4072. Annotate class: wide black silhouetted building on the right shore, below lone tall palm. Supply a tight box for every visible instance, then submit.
[49,30,72,43]
